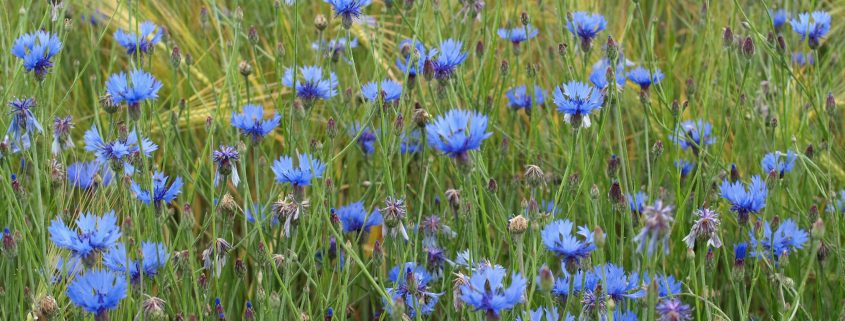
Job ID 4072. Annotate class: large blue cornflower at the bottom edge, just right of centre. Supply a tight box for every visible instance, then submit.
[460,265,527,318]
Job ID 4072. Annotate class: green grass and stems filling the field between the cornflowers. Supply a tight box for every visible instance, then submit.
[0,0,845,320]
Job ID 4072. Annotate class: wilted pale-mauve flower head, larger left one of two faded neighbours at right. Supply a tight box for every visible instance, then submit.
[634,200,675,256]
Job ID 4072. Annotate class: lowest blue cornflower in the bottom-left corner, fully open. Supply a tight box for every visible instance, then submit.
[67,270,127,320]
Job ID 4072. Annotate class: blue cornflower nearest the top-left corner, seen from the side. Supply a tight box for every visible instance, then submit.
[12,31,62,81]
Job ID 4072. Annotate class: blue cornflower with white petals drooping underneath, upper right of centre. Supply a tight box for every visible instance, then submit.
[553,81,604,128]
